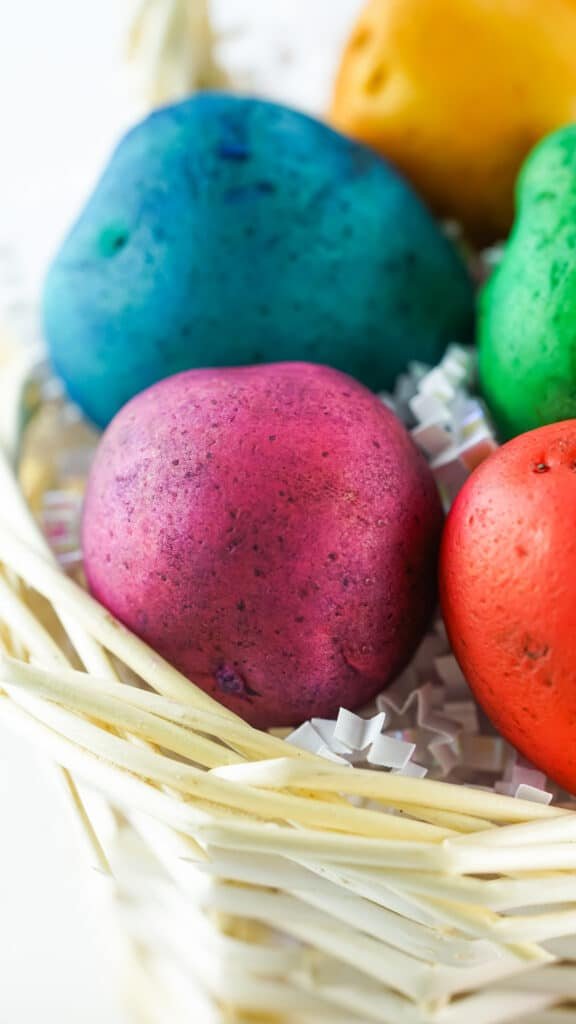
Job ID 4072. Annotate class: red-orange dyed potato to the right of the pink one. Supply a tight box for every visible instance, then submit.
[441,420,576,793]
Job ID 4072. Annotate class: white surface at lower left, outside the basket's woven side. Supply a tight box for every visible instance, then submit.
[0,731,120,1024]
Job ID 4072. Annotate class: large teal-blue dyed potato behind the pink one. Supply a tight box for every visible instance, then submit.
[43,93,474,426]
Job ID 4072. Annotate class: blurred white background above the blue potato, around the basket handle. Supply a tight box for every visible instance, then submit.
[0,0,362,296]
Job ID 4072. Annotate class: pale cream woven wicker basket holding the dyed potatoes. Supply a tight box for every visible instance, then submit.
[0,337,576,1024]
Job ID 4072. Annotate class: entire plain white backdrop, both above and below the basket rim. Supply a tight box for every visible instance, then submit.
[0,0,360,1024]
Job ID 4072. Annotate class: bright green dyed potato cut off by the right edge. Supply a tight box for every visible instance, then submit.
[480,125,576,437]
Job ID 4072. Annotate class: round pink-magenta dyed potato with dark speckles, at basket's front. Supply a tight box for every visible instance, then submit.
[83,364,443,728]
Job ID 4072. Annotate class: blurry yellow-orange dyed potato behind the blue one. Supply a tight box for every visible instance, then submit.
[331,0,576,243]
